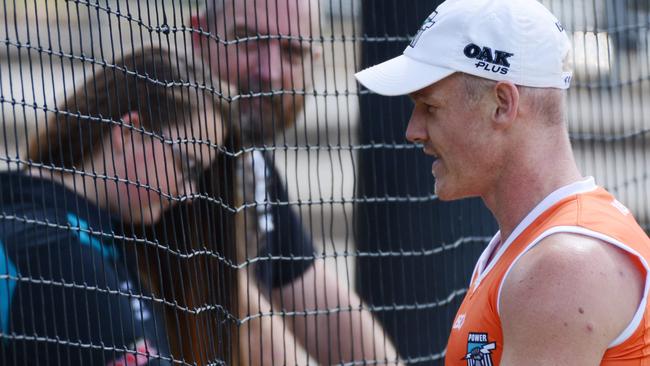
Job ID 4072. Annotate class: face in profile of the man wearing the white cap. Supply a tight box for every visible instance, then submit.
[406,74,501,201]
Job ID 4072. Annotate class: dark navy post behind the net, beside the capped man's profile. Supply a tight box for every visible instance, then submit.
[352,0,497,366]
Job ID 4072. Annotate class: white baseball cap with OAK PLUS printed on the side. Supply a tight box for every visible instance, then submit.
[355,0,572,96]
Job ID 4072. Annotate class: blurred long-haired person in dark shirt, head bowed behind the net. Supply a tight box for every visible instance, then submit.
[0,47,229,366]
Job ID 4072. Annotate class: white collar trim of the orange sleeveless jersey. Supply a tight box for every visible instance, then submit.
[472,177,598,290]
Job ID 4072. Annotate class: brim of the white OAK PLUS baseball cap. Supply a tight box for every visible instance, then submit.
[354,55,455,96]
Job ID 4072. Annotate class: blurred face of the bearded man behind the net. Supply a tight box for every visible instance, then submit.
[198,0,315,145]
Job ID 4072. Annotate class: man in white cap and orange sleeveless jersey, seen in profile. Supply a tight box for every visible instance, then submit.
[356,0,650,366]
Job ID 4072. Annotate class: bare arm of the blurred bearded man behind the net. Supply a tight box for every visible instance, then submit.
[273,260,398,365]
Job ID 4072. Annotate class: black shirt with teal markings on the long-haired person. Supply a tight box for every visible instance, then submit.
[0,172,171,365]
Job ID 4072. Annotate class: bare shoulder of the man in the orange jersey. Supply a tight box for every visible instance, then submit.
[499,233,645,364]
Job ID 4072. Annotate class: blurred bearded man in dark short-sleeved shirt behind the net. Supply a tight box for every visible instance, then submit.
[192,0,397,364]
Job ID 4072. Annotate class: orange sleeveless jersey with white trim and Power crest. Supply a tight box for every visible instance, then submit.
[445,178,650,366]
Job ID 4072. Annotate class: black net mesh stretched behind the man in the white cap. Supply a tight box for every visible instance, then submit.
[0,0,650,365]
